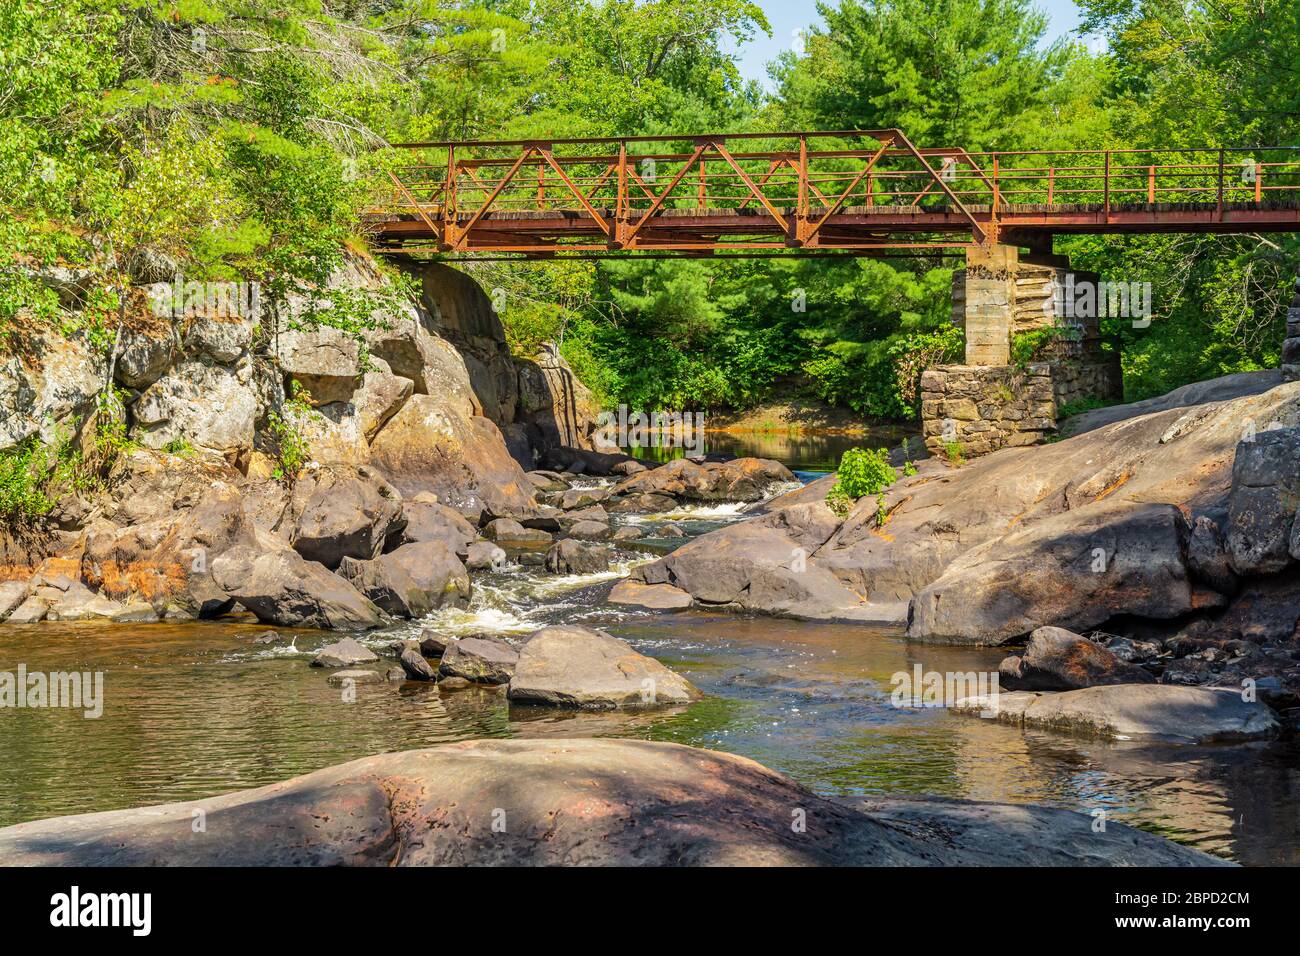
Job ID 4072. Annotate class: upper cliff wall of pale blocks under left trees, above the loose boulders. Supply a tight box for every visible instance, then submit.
[0,256,595,476]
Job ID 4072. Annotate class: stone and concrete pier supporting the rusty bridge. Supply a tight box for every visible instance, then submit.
[920,246,1123,458]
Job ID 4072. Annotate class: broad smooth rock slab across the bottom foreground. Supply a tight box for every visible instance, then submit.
[0,739,1222,866]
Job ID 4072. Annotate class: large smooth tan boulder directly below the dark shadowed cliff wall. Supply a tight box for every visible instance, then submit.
[371,395,537,522]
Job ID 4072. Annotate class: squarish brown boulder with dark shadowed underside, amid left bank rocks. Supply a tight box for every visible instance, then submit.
[281,463,406,568]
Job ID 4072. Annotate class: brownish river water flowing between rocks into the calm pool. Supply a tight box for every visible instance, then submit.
[0,470,1300,864]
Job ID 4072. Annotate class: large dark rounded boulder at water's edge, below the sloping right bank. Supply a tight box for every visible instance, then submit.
[907,502,1213,644]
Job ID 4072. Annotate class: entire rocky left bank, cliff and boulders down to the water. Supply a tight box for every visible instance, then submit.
[0,256,611,628]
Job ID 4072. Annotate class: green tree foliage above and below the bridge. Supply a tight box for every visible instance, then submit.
[0,0,1300,418]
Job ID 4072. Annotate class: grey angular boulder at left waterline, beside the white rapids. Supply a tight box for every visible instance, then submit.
[338,541,469,618]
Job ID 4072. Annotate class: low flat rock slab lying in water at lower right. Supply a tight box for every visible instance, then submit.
[953,684,1279,744]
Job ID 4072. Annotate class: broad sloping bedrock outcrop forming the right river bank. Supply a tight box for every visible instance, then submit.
[650,373,1300,644]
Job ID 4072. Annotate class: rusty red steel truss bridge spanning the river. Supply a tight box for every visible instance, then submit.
[364,129,1300,259]
